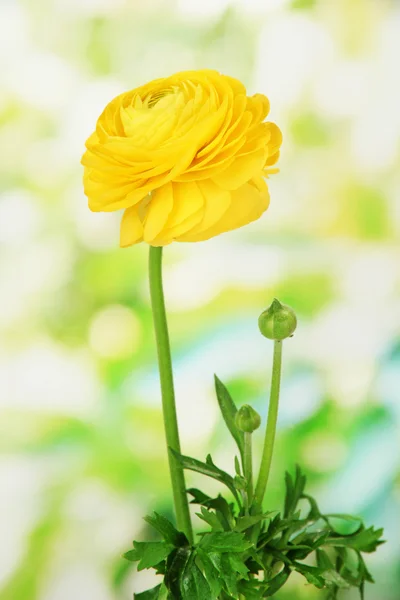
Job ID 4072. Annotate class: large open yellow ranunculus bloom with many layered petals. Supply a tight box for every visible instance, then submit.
[82,70,282,247]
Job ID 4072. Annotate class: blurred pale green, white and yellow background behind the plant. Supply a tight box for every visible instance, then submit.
[0,0,400,600]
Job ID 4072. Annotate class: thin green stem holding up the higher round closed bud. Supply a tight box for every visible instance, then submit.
[253,340,282,510]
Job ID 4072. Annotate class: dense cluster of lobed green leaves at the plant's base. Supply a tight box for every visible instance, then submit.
[125,466,383,600]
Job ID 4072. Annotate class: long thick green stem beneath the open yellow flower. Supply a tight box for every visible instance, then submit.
[149,246,193,543]
